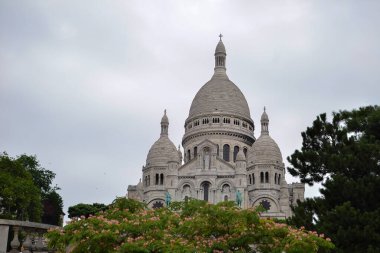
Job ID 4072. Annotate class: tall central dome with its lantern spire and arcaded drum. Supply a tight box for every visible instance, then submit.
[182,39,255,148]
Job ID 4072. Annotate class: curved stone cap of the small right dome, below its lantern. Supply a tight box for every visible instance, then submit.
[248,135,282,165]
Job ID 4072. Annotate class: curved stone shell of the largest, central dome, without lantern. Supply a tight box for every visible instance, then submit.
[189,74,251,120]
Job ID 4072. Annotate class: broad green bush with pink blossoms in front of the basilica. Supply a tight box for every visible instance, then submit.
[47,198,333,253]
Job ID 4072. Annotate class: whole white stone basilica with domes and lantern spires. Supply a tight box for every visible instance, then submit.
[128,36,305,219]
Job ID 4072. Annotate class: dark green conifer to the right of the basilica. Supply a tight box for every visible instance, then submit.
[288,106,380,252]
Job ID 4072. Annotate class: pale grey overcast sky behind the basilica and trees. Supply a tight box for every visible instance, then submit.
[0,0,380,217]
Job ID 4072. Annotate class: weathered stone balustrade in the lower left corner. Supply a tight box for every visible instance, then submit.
[0,219,56,253]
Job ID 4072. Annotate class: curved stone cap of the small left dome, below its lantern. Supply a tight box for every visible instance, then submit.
[146,136,179,166]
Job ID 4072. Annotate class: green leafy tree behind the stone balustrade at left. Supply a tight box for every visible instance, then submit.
[0,153,63,225]
